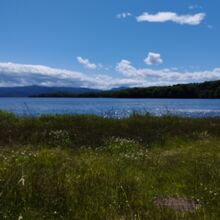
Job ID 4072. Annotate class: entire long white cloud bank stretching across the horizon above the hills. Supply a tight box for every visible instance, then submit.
[0,60,220,89]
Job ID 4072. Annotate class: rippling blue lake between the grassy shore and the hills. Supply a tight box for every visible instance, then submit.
[0,98,220,118]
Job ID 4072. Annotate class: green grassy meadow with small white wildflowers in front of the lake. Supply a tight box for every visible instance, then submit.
[0,112,220,220]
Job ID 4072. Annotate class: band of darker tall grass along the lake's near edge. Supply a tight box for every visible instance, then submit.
[0,112,220,147]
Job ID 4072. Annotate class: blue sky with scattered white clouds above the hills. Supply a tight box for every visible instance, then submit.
[0,0,220,89]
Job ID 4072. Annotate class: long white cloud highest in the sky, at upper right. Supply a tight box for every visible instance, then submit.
[136,12,206,25]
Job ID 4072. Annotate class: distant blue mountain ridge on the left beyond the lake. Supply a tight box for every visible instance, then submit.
[0,86,101,97]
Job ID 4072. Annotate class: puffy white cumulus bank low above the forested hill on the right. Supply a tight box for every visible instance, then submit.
[116,60,220,84]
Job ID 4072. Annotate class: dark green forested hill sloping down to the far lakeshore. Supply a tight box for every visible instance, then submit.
[32,80,220,98]
